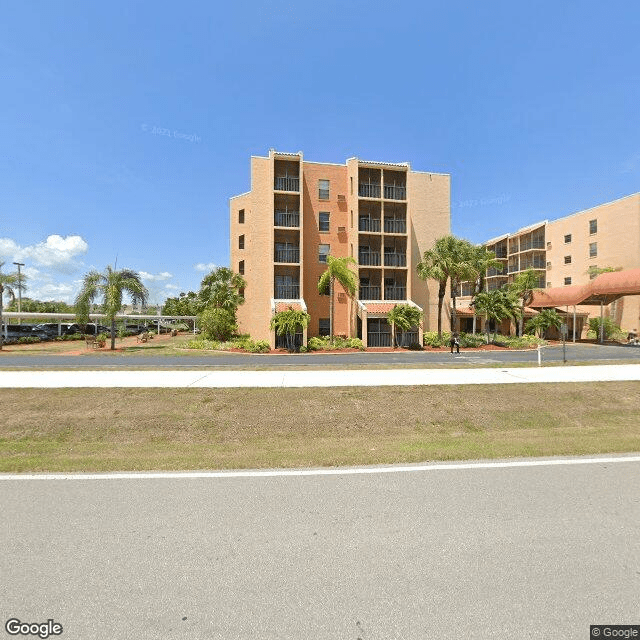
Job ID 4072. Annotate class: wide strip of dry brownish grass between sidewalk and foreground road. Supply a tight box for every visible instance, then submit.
[0,382,640,472]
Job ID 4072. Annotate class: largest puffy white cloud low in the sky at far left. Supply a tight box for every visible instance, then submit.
[0,234,89,273]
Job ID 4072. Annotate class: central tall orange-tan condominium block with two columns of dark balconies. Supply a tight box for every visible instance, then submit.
[230,150,451,346]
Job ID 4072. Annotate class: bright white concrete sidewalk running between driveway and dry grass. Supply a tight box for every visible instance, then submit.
[0,364,640,389]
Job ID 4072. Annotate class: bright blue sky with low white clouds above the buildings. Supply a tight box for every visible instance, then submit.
[0,0,640,302]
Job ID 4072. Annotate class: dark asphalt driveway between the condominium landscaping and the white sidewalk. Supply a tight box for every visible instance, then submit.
[0,344,640,369]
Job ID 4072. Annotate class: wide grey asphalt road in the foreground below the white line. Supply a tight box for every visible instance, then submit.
[0,462,640,640]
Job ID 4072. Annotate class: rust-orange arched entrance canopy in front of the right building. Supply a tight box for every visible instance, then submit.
[529,269,640,309]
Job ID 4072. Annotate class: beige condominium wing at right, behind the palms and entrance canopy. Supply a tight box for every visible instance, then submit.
[461,193,640,331]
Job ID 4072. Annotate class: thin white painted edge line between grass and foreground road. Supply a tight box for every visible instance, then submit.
[0,455,640,480]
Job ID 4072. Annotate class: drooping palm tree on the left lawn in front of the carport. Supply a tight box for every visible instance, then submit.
[75,266,149,351]
